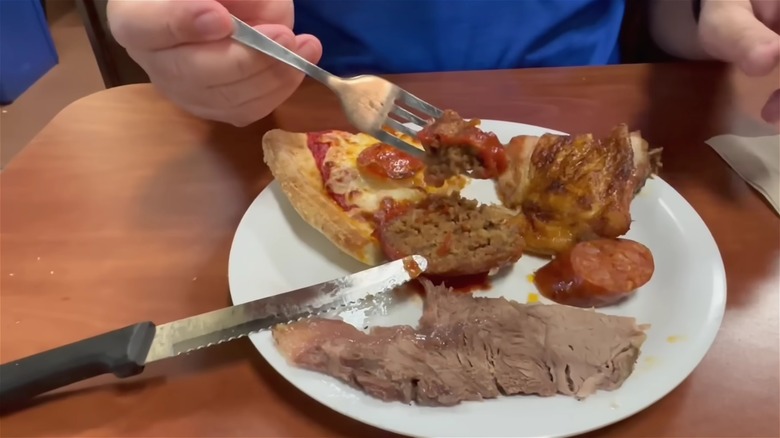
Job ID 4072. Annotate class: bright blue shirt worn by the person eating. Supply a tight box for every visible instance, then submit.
[294,0,626,76]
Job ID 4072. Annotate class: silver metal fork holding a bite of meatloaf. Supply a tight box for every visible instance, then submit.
[232,16,442,156]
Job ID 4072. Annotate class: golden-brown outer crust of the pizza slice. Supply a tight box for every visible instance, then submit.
[263,129,385,266]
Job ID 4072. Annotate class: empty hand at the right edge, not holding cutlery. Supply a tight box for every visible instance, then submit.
[698,0,780,123]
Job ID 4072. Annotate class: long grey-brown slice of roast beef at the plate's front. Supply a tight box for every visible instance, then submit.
[273,280,646,406]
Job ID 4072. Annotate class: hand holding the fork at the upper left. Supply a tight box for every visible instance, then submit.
[107,0,322,126]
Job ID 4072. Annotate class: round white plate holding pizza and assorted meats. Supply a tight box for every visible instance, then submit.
[228,120,726,437]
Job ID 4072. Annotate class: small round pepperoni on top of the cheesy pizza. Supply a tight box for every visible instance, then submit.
[357,143,423,180]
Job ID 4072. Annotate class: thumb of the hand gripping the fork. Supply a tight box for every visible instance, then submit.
[106,0,233,50]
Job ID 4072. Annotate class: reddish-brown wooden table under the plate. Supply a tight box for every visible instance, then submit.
[0,64,780,437]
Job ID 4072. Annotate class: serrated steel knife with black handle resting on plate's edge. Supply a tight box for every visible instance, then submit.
[0,255,428,406]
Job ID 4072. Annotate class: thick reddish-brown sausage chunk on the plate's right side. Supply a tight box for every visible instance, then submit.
[534,239,655,308]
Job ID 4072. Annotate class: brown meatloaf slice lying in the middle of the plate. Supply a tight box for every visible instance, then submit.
[379,194,523,276]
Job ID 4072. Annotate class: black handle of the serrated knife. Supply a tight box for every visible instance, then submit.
[0,322,156,407]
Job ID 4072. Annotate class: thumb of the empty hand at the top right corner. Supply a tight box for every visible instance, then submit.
[699,0,780,76]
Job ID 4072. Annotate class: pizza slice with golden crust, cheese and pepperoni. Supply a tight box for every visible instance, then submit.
[263,129,467,265]
